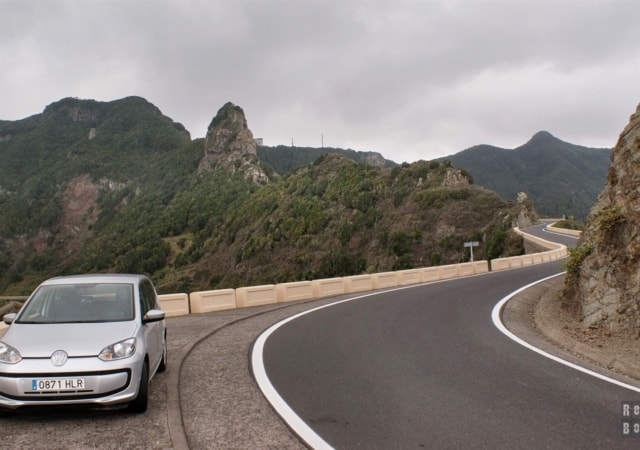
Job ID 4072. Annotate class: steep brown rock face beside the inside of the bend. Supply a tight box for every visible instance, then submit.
[565,102,640,336]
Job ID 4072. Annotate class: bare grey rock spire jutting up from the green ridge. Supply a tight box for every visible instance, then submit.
[198,102,269,184]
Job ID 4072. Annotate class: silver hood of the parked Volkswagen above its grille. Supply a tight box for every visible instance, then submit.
[2,321,136,358]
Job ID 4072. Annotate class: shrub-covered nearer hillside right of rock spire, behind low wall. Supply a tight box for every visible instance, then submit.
[162,155,523,288]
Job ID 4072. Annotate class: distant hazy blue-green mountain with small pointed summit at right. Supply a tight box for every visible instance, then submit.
[442,131,611,220]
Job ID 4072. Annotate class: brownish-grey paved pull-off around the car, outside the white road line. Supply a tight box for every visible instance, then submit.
[0,300,327,450]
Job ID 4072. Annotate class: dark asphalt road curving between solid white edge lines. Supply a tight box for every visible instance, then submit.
[254,230,640,449]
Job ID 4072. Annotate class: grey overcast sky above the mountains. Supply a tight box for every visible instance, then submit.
[0,0,640,162]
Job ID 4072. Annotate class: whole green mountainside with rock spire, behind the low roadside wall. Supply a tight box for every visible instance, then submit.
[0,97,535,295]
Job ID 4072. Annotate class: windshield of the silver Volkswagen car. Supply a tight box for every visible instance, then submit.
[15,283,133,323]
